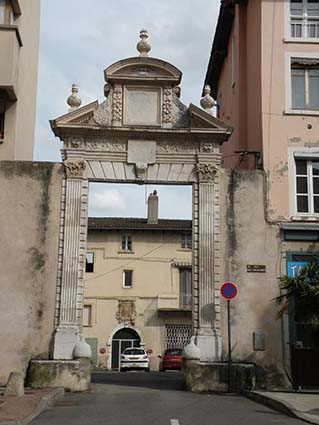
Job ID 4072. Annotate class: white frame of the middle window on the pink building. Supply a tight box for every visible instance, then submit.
[284,52,319,115]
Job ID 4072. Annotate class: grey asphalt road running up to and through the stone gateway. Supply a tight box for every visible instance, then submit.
[32,372,304,425]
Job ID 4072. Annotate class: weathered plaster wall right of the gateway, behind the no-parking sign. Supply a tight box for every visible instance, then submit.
[221,170,283,385]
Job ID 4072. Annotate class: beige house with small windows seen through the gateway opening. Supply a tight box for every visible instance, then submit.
[83,195,192,370]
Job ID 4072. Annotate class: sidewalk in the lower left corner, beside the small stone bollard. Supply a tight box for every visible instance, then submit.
[0,388,64,425]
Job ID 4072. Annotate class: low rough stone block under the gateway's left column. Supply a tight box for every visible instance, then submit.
[27,359,92,392]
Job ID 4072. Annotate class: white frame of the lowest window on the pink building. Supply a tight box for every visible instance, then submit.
[288,148,319,221]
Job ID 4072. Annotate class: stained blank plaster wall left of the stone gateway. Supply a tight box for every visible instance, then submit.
[0,161,62,385]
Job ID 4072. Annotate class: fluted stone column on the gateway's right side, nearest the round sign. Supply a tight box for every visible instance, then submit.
[196,163,221,361]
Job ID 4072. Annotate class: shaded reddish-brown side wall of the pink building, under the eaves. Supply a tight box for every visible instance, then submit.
[216,0,262,168]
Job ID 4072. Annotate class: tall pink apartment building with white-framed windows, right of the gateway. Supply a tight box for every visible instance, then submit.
[205,0,319,385]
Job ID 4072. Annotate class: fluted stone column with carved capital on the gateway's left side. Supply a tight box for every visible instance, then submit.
[53,160,88,360]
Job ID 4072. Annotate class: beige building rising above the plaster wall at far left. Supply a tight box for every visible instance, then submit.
[0,0,40,161]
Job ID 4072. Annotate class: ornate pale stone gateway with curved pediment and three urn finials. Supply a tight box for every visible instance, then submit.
[51,31,231,361]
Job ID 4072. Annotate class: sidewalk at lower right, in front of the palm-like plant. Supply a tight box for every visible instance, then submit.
[245,391,319,424]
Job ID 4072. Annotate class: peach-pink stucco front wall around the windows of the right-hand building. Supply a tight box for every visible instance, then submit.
[261,0,319,220]
